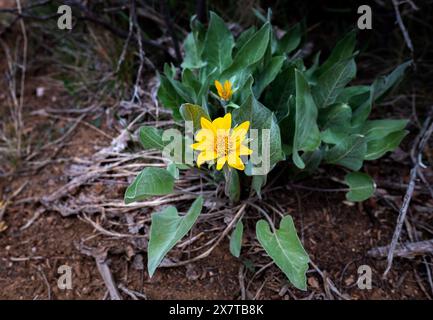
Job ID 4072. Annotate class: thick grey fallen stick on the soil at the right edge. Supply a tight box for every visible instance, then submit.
[367,239,433,258]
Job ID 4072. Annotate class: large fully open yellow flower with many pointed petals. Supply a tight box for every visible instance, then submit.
[191,113,253,170]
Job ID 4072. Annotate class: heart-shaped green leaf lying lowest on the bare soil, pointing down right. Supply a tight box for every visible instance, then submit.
[256,216,310,290]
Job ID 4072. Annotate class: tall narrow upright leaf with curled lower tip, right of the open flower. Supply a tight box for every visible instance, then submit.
[292,70,320,169]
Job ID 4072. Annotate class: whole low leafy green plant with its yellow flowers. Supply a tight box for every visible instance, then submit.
[125,12,410,290]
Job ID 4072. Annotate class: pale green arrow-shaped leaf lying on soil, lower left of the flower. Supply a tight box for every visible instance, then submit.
[147,196,203,277]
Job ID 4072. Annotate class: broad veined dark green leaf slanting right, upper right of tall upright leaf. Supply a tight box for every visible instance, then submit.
[313,58,356,109]
